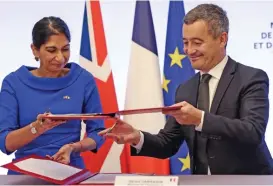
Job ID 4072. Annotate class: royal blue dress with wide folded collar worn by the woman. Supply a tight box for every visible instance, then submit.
[0,63,104,174]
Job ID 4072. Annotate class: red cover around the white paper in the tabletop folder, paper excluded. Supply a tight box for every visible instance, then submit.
[2,155,95,185]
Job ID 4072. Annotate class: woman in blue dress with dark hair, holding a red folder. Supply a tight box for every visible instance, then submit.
[0,17,104,174]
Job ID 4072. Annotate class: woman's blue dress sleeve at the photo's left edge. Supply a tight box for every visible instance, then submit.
[0,79,19,155]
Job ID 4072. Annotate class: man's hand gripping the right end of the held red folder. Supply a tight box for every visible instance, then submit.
[163,101,202,126]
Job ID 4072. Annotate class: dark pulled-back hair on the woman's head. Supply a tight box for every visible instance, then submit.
[32,16,71,49]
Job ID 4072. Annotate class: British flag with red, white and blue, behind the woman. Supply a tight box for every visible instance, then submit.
[80,1,127,172]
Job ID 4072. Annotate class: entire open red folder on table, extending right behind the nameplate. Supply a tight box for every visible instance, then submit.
[2,155,154,185]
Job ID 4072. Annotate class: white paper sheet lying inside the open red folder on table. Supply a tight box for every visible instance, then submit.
[14,158,81,180]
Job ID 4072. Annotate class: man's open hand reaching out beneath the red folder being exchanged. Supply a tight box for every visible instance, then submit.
[98,118,140,145]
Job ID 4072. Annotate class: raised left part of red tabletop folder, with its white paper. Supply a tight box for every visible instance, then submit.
[2,155,95,185]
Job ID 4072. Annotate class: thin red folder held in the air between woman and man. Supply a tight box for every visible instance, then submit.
[39,106,181,120]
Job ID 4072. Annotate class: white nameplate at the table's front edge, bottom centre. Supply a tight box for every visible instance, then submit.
[115,176,178,186]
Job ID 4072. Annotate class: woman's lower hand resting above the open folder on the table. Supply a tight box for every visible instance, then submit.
[47,144,73,164]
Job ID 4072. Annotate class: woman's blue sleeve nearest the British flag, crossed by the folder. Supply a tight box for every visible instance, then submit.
[83,77,105,152]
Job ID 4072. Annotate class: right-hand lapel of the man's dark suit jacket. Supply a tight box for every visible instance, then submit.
[210,58,237,114]
